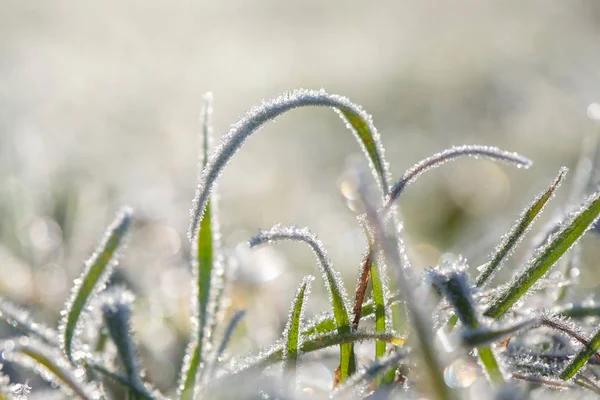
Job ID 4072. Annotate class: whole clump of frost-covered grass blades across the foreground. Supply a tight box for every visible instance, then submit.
[0,90,600,400]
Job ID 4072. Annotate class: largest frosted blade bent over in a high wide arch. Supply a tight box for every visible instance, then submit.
[189,89,389,242]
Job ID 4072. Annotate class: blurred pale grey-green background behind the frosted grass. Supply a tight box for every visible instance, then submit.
[0,0,600,389]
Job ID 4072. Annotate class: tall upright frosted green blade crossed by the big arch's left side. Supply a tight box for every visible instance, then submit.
[178,93,223,400]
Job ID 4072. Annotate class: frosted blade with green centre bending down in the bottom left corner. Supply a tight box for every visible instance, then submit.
[2,337,102,400]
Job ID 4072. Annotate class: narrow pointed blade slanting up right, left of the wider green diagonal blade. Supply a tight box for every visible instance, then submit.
[475,167,569,287]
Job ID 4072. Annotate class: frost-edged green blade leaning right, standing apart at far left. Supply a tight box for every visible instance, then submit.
[59,208,132,362]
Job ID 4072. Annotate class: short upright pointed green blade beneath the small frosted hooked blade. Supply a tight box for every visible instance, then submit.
[283,276,314,388]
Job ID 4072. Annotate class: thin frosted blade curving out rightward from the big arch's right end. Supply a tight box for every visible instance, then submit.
[384,145,532,210]
